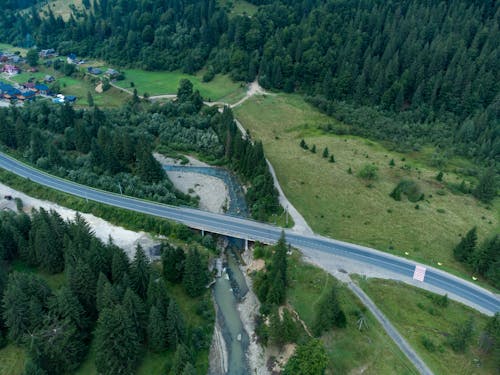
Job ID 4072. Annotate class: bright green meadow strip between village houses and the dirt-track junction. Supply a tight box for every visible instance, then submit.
[116,69,245,102]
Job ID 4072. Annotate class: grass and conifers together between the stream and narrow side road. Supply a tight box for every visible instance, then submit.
[253,242,417,374]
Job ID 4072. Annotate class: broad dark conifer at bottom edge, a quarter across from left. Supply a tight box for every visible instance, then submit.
[95,305,143,375]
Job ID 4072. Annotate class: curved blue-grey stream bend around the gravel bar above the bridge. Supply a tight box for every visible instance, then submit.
[163,165,248,217]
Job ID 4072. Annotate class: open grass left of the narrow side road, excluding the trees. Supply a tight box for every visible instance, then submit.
[288,252,417,375]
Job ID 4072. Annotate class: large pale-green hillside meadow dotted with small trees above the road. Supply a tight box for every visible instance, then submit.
[234,94,500,277]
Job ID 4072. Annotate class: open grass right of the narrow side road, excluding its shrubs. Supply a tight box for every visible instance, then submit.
[359,278,495,375]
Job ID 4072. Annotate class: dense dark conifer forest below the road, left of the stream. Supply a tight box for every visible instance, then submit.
[0,208,214,375]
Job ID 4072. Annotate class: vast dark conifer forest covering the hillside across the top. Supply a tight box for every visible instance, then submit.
[0,0,500,166]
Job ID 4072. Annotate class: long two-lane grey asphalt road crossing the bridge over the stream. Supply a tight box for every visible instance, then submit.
[0,153,500,314]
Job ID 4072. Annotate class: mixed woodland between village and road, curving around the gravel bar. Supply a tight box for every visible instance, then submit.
[0,80,281,221]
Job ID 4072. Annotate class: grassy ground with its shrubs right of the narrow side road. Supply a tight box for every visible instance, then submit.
[357,277,500,374]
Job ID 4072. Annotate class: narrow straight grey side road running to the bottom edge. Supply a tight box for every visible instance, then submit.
[347,282,433,375]
